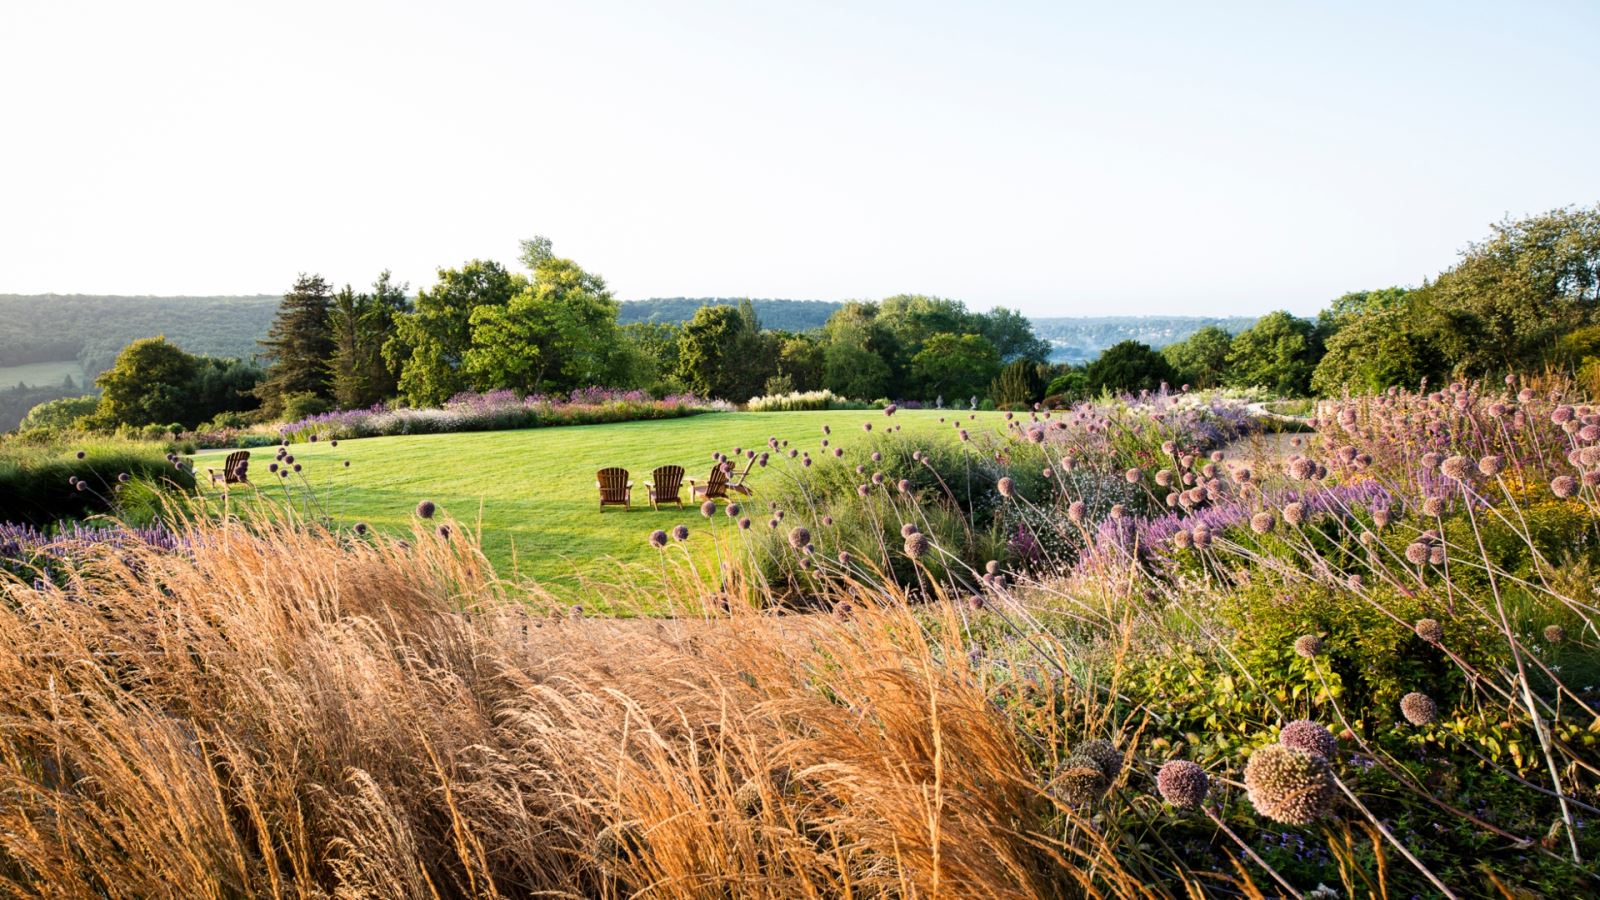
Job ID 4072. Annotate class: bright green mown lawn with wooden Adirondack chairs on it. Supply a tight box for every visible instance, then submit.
[195,410,1003,593]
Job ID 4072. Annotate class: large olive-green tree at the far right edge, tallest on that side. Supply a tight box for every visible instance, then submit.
[1421,207,1600,376]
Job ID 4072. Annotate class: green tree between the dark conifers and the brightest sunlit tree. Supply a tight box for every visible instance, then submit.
[384,259,526,407]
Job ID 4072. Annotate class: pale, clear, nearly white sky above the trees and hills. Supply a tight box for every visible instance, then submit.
[0,0,1600,315]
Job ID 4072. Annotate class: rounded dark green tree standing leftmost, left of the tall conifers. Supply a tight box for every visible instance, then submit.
[94,336,200,428]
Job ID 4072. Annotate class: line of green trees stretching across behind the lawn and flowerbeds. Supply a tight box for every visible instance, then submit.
[25,207,1600,428]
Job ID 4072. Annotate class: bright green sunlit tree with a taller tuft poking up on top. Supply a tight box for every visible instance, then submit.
[464,249,624,394]
